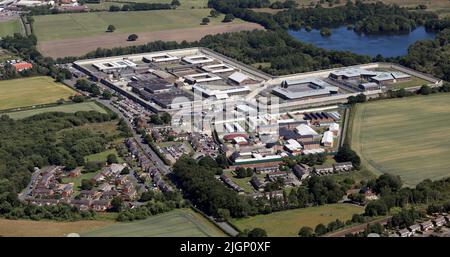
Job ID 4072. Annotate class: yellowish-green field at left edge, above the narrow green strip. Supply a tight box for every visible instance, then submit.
[0,76,76,110]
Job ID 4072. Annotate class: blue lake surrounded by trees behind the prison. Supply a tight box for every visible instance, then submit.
[289,26,436,57]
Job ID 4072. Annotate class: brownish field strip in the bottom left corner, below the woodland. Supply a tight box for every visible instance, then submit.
[0,219,113,237]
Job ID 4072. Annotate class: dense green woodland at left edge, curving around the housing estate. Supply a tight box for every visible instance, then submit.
[0,111,121,219]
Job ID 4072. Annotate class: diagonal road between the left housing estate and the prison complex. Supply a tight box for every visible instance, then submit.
[97,99,171,175]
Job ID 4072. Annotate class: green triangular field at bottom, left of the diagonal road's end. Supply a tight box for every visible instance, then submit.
[81,209,226,237]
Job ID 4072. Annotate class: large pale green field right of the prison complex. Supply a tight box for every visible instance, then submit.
[351,94,450,186]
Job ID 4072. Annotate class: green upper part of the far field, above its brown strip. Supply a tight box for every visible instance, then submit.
[33,9,239,41]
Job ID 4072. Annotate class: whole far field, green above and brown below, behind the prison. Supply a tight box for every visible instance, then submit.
[33,9,262,57]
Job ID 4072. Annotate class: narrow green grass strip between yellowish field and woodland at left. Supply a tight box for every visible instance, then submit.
[1,102,106,119]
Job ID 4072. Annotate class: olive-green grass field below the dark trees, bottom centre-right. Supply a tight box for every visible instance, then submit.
[232,204,364,236]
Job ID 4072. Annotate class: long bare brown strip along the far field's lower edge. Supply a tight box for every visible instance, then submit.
[38,22,264,58]
